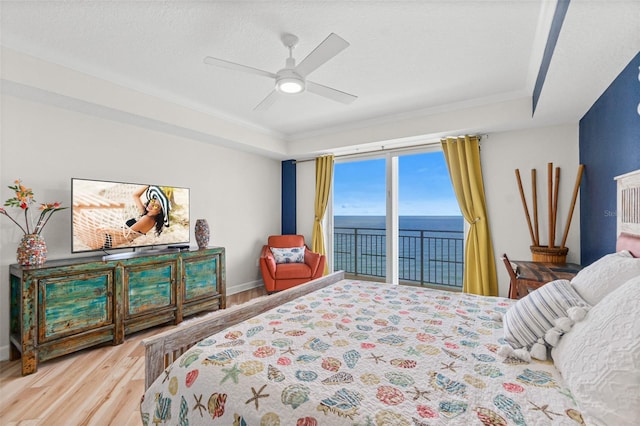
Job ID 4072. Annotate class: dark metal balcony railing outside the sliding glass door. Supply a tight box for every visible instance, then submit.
[333,227,464,288]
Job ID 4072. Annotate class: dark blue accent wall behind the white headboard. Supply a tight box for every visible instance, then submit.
[579,53,640,265]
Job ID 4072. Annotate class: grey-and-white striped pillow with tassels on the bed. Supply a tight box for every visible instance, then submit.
[502,280,589,349]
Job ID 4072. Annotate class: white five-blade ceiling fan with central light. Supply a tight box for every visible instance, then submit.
[204,33,358,111]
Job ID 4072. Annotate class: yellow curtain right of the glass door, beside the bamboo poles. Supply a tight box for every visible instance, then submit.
[441,136,498,296]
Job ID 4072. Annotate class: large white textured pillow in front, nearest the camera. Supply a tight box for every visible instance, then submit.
[551,277,640,426]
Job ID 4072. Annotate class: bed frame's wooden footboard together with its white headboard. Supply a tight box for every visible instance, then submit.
[142,169,640,389]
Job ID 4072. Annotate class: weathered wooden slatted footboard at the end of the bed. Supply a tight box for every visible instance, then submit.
[141,271,344,390]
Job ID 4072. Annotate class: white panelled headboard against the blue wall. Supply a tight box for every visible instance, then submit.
[615,169,640,257]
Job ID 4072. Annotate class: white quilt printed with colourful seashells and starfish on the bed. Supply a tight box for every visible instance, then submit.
[140,280,584,426]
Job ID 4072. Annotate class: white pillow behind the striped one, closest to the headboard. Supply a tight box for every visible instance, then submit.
[571,250,640,306]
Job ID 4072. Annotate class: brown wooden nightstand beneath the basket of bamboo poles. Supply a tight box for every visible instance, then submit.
[504,255,582,299]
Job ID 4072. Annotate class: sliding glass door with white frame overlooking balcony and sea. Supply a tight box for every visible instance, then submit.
[332,149,464,288]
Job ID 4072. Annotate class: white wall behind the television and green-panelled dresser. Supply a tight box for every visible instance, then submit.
[0,94,281,359]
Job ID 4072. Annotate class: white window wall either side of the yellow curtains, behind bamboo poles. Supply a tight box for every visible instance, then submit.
[297,124,580,297]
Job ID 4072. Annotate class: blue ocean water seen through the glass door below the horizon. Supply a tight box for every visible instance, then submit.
[334,216,464,287]
